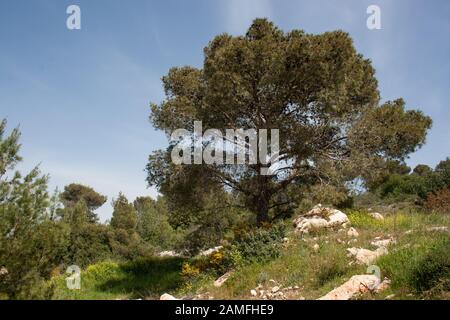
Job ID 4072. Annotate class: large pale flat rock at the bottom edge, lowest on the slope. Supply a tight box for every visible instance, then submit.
[318,274,389,300]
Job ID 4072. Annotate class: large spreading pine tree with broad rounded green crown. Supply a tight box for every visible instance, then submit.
[147,19,431,223]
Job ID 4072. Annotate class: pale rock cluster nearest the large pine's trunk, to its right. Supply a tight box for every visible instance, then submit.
[294,204,350,235]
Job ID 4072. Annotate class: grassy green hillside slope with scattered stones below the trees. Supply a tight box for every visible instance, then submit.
[49,212,450,299]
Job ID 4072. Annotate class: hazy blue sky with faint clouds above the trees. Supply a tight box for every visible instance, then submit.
[0,0,450,220]
